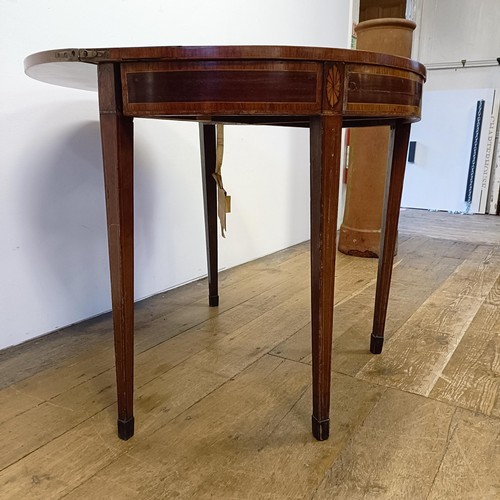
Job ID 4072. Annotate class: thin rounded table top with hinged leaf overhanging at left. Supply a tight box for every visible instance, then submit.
[24,45,426,91]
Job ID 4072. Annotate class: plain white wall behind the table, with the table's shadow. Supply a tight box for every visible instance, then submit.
[0,0,351,348]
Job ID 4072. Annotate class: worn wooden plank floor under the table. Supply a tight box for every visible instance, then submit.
[0,211,500,500]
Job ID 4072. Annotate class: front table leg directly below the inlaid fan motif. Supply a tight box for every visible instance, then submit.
[311,116,342,441]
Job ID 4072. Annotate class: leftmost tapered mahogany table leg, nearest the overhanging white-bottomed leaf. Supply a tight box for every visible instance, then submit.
[98,63,134,439]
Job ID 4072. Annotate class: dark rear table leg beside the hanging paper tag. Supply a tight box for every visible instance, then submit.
[200,123,219,307]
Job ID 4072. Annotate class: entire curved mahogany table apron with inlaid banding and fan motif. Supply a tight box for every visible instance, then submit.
[120,61,423,122]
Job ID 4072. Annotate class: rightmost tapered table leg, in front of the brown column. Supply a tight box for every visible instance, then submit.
[370,124,410,354]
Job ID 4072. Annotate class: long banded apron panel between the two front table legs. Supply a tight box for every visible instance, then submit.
[121,61,323,116]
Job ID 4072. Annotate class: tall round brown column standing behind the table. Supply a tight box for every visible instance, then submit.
[339,19,416,257]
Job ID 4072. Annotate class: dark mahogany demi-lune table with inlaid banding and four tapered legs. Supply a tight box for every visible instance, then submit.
[25,46,425,440]
